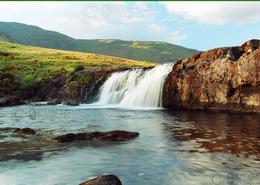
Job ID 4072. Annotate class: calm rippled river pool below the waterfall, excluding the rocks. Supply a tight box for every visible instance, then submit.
[0,105,260,185]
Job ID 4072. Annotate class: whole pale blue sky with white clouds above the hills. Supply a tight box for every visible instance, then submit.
[0,2,260,50]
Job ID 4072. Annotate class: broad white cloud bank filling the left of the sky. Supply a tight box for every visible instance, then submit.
[0,2,186,43]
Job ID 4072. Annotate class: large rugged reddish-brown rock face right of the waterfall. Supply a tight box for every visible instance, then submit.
[163,40,260,112]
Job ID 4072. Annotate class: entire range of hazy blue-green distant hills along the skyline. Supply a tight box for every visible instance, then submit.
[0,22,198,63]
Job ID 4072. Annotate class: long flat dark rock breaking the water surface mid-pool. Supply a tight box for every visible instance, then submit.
[54,130,139,143]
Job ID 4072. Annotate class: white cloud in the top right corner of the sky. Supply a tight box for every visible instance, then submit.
[163,2,260,25]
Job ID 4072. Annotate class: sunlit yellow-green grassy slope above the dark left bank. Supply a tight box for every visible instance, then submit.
[0,41,157,84]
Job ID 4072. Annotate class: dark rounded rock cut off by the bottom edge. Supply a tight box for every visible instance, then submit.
[80,175,122,185]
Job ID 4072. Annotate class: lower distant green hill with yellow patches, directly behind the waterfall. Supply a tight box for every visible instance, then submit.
[77,40,197,63]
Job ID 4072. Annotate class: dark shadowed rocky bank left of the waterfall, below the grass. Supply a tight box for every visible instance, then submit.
[0,68,126,107]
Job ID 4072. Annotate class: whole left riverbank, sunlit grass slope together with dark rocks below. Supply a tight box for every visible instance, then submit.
[0,42,157,106]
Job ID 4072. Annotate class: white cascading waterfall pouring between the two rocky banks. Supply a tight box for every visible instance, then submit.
[98,64,172,107]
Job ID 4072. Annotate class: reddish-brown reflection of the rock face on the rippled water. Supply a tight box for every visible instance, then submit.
[164,111,260,159]
